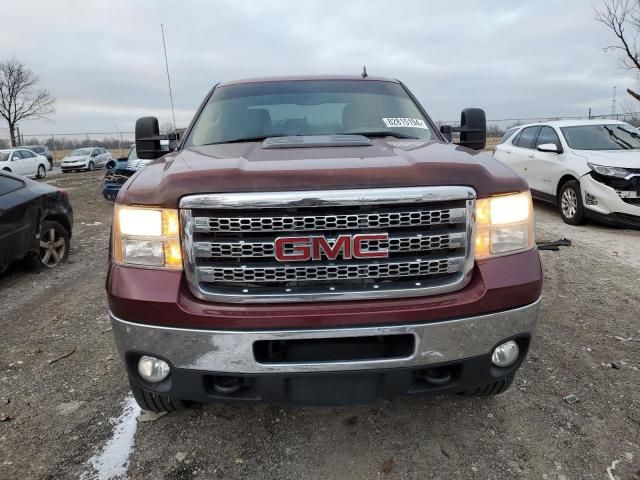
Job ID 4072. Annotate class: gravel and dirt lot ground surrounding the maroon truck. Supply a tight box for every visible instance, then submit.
[0,172,640,480]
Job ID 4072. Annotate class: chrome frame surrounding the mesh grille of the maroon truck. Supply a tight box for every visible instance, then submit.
[180,186,476,304]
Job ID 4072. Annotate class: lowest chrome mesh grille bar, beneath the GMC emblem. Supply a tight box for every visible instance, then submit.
[197,257,464,283]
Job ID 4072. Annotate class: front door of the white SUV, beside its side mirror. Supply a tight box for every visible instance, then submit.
[526,125,564,196]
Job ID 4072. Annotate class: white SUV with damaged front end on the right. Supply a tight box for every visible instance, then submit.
[494,120,640,228]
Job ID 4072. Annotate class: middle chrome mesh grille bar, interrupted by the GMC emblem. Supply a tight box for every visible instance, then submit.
[193,232,467,258]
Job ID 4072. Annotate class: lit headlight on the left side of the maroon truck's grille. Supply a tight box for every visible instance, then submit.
[113,205,182,270]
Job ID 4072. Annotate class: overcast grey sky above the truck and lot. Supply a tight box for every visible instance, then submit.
[0,0,635,136]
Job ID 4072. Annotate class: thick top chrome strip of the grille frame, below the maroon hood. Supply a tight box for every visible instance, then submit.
[180,186,476,209]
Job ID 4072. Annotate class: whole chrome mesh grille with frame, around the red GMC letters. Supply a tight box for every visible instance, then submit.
[180,187,475,303]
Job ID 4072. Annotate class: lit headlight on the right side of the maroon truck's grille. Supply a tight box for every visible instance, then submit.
[475,191,535,260]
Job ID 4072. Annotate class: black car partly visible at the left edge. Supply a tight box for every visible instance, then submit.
[0,171,73,273]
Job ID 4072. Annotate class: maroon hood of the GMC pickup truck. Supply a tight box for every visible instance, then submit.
[117,139,528,208]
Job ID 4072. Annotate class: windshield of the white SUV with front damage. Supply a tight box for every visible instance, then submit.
[560,124,640,150]
